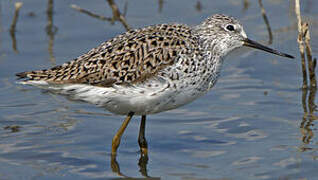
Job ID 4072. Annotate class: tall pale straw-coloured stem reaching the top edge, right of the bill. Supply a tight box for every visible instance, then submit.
[295,0,308,88]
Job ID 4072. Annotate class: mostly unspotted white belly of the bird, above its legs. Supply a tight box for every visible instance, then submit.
[21,80,209,115]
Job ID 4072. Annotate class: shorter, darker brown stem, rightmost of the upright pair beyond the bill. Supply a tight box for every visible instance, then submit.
[302,23,317,88]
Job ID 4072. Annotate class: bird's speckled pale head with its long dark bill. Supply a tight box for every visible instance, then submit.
[195,14,294,58]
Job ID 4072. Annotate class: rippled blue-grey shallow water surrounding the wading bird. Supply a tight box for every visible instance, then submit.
[0,0,318,180]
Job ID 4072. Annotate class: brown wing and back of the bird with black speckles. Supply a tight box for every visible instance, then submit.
[17,24,197,87]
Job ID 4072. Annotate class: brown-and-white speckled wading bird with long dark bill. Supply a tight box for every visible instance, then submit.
[17,14,292,154]
